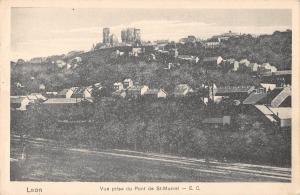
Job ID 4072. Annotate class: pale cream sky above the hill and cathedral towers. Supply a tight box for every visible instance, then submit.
[11,8,292,59]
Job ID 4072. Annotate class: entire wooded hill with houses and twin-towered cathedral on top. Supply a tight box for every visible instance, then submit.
[10,28,292,167]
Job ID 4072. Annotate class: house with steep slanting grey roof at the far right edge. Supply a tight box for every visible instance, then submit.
[257,87,292,108]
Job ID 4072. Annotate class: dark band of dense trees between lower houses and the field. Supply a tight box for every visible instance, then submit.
[11,99,291,167]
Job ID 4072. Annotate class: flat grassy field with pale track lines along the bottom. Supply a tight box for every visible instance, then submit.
[11,136,290,182]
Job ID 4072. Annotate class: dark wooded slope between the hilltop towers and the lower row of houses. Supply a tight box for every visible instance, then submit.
[11,31,292,94]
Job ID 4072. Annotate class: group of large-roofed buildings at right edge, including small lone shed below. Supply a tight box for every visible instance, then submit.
[203,80,292,130]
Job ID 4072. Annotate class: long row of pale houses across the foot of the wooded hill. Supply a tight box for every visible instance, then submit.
[11,68,292,129]
